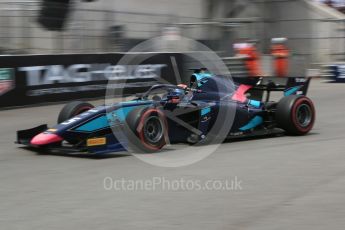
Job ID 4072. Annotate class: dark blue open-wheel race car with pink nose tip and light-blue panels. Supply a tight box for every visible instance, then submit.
[17,70,315,154]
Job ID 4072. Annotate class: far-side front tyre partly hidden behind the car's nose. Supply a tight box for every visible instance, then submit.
[57,101,94,124]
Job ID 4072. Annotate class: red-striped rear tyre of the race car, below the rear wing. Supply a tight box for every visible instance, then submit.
[276,95,315,135]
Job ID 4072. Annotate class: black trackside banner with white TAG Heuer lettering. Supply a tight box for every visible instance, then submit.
[0,53,181,107]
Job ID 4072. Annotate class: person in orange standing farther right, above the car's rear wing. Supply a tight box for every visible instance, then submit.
[271,38,290,77]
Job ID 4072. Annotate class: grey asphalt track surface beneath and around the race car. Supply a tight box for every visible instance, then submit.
[0,80,345,230]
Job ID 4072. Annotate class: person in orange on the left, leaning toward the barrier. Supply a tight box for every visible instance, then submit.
[234,43,262,77]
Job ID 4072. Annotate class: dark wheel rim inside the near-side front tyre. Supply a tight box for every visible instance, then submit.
[144,116,163,144]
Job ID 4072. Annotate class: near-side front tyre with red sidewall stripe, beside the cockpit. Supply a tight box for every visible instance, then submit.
[126,108,168,153]
